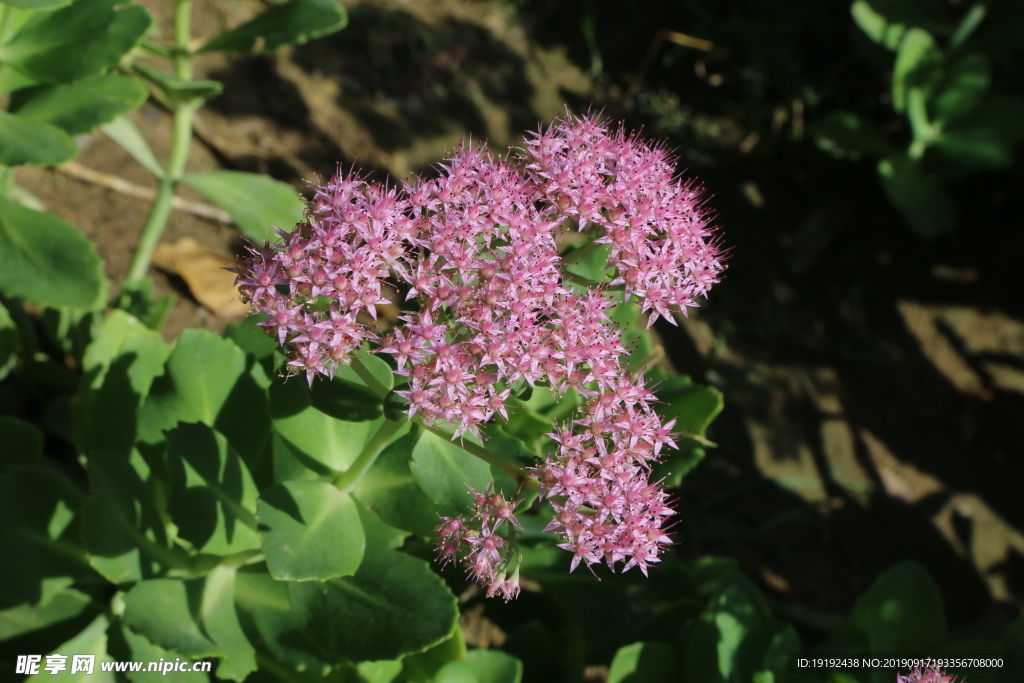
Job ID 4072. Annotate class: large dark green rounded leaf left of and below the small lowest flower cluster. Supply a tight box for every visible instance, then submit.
[288,546,459,661]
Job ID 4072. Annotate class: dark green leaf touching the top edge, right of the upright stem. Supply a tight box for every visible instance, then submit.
[200,0,348,53]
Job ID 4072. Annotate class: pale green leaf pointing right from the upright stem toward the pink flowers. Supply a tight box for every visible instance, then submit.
[181,171,306,243]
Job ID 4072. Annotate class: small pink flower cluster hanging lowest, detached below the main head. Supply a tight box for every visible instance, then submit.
[435,486,522,602]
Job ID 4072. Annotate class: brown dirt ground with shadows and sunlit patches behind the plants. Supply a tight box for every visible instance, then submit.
[17,0,1024,651]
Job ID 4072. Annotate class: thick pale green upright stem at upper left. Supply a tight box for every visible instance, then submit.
[122,0,199,288]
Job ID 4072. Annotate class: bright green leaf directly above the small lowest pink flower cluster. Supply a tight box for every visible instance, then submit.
[411,429,493,510]
